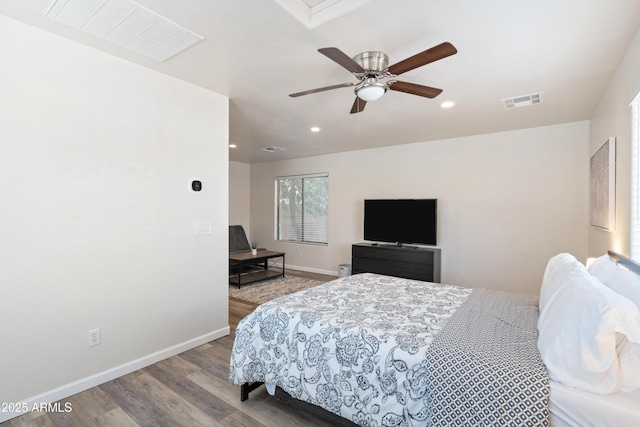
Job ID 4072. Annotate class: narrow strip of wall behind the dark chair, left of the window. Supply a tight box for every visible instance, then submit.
[229,162,251,239]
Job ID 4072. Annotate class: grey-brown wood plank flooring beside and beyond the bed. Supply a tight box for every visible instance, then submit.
[0,270,355,427]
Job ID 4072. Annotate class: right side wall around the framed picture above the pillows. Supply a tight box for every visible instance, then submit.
[589,26,640,257]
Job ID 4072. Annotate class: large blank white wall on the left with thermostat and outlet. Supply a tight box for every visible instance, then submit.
[0,16,229,421]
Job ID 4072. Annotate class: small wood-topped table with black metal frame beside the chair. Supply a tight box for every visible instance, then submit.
[229,250,284,289]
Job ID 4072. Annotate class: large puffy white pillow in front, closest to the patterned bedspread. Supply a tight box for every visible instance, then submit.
[538,254,640,394]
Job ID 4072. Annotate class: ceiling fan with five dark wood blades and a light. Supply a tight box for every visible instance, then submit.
[289,42,458,114]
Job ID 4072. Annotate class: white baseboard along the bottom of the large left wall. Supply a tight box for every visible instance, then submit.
[0,325,231,423]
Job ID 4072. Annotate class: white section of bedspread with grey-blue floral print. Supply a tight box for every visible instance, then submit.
[229,273,472,426]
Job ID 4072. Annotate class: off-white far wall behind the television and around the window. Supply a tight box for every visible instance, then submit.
[251,122,589,294]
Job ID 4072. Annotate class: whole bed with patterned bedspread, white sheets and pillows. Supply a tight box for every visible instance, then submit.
[229,254,640,427]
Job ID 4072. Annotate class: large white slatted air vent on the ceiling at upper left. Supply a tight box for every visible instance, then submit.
[45,0,204,62]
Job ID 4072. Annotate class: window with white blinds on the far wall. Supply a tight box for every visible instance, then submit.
[275,174,329,244]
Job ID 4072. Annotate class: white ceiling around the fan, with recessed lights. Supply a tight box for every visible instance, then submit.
[0,0,640,163]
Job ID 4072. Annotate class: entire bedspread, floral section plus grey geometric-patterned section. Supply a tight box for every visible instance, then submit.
[229,274,549,427]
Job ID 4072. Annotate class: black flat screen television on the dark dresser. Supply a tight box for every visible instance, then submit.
[364,199,438,246]
